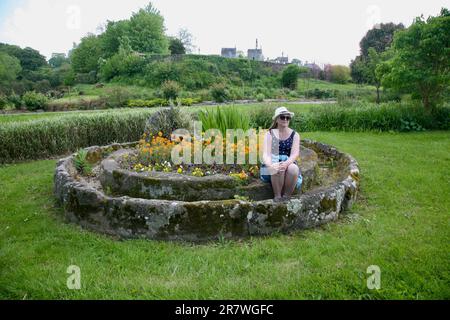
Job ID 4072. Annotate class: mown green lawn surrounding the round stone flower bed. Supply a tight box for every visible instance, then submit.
[0,132,450,299]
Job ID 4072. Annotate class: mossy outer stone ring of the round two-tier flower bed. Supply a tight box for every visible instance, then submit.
[55,140,359,242]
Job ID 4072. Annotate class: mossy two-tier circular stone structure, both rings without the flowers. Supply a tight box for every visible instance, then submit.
[54,140,359,242]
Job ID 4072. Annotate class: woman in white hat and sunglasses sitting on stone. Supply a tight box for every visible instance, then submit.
[261,107,302,202]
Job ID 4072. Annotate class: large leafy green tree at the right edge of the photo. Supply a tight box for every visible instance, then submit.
[377,8,450,109]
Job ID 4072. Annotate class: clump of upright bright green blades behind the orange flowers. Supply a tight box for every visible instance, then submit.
[199,106,250,135]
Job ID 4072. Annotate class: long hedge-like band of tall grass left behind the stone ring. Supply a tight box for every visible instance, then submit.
[0,110,153,163]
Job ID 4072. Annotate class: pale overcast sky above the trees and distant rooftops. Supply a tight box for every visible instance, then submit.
[0,0,450,65]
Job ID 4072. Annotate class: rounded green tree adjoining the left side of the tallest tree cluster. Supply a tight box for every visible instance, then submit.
[70,34,102,73]
